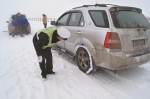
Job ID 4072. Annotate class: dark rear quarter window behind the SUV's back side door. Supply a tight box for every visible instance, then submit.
[89,10,109,28]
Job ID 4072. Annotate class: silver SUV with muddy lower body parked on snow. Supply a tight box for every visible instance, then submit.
[51,4,150,73]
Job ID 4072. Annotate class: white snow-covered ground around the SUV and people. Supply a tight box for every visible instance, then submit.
[0,20,150,99]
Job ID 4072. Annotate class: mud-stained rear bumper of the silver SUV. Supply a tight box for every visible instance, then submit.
[96,51,150,70]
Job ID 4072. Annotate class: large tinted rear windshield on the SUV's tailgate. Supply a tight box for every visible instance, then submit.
[111,11,150,28]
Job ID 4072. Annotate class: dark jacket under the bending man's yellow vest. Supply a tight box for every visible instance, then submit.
[33,30,59,56]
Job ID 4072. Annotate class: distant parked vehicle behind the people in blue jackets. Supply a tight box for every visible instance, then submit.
[6,14,31,35]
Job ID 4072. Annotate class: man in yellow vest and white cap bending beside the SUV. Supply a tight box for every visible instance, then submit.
[33,27,70,78]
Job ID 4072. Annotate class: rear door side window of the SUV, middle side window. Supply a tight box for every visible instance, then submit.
[69,12,82,26]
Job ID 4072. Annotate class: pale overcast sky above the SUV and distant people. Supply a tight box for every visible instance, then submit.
[0,0,150,18]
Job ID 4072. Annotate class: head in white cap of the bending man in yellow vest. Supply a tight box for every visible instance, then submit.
[57,27,70,41]
